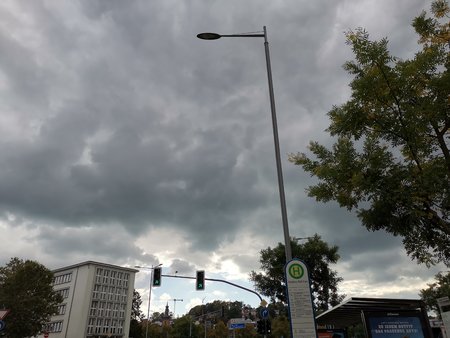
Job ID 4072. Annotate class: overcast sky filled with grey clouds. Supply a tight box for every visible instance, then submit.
[0,0,446,314]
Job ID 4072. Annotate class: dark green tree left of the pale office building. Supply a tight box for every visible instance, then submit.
[0,258,62,338]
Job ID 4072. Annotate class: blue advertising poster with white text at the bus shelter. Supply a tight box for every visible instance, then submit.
[363,311,430,338]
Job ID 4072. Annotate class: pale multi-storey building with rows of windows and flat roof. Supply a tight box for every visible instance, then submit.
[38,261,138,338]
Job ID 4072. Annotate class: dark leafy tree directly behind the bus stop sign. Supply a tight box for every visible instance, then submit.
[250,234,344,311]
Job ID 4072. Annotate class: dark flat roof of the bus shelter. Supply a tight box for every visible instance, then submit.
[316,297,425,328]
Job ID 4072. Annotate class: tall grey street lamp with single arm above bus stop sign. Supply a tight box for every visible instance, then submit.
[197,26,292,262]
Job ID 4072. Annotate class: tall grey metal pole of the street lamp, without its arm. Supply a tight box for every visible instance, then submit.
[264,26,292,263]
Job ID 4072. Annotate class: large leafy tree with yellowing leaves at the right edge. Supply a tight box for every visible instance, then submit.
[290,0,450,265]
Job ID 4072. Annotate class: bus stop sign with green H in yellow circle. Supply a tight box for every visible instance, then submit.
[284,258,317,338]
